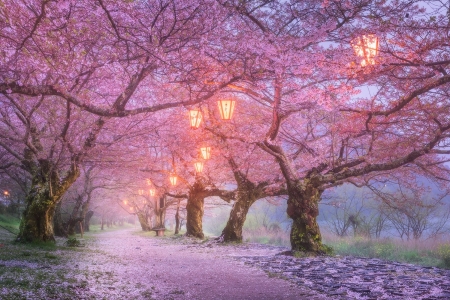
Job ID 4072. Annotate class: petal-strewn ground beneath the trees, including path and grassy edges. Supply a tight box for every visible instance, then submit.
[0,228,450,299]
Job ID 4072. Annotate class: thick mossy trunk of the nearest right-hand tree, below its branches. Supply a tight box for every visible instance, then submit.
[287,179,329,254]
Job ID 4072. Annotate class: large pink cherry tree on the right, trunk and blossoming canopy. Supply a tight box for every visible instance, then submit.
[209,1,450,253]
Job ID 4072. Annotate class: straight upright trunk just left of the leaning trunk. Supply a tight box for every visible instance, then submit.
[186,180,205,239]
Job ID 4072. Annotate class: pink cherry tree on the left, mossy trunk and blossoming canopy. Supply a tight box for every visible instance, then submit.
[0,0,235,241]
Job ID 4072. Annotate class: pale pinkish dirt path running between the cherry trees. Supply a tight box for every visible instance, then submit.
[77,229,320,299]
